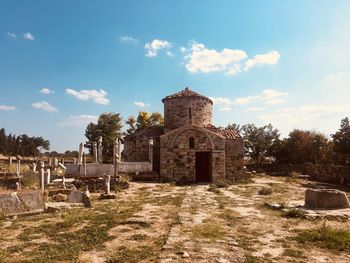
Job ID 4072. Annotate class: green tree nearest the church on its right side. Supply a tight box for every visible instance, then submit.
[241,124,280,163]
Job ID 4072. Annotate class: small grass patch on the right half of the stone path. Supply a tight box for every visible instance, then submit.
[192,222,226,241]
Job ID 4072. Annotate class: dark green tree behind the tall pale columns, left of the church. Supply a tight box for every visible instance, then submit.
[85,113,122,161]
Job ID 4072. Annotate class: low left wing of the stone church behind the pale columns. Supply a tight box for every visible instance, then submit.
[123,127,164,172]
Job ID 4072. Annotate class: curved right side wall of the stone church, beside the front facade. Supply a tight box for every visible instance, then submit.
[225,139,244,178]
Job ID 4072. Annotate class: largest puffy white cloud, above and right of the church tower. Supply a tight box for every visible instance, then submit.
[185,42,247,74]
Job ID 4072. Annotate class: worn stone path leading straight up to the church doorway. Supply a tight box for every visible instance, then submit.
[159,185,243,263]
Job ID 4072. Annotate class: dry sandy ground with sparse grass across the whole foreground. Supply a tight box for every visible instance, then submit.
[0,176,350,263]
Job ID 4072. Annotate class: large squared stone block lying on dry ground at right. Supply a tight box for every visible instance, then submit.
[305,189,350,209]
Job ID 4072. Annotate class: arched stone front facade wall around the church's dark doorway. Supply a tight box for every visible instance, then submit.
[160,128,225,183]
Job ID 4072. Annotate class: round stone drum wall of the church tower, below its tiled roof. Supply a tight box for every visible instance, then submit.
[164,97,212,132]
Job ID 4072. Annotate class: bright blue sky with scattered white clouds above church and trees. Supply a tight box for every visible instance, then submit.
[0,0,350,151]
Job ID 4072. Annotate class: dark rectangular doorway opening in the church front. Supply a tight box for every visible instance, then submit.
[196,152,212,183]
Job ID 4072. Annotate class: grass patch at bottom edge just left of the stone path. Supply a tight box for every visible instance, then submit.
[106,246,154,263]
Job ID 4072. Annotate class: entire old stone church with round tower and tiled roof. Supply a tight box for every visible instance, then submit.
[124,88,244,183]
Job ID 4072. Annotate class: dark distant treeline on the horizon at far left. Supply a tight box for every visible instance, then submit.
[0,128,50,156]
